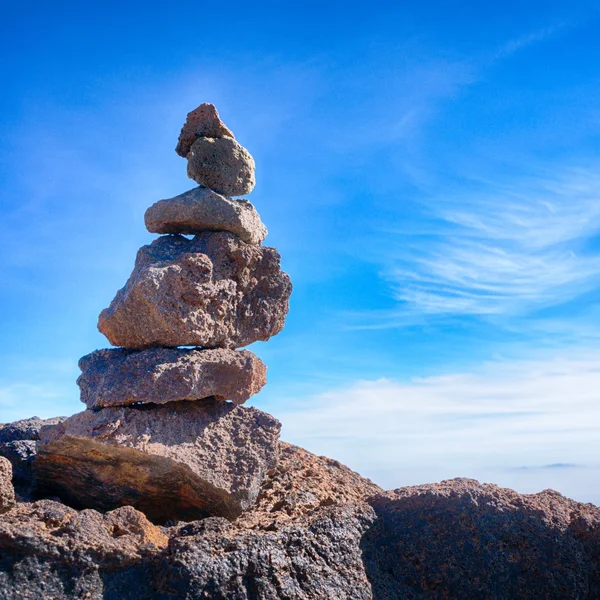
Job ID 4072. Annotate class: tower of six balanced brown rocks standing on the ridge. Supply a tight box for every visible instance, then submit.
[34,104,291,522]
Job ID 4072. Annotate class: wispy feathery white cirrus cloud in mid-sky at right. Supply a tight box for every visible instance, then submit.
[386,169,600,315]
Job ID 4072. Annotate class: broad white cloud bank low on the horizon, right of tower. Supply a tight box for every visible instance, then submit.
[277,349,600,503]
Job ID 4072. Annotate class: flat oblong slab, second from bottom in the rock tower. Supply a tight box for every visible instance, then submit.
[77,348,267,408]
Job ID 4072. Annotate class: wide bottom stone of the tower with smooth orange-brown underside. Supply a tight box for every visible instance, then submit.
[34,400,281,522]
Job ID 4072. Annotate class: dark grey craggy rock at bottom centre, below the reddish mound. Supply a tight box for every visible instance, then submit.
[163,504,373,600]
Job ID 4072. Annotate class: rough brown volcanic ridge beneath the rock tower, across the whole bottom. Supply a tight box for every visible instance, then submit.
[0,427,600,600]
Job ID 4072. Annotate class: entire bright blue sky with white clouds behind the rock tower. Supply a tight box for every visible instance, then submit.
[0,1,600,503]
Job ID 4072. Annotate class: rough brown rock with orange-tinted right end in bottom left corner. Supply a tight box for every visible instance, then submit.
[0,500,168,600]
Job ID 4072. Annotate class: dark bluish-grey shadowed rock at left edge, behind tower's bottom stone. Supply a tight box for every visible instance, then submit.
[0,417,65,499]
